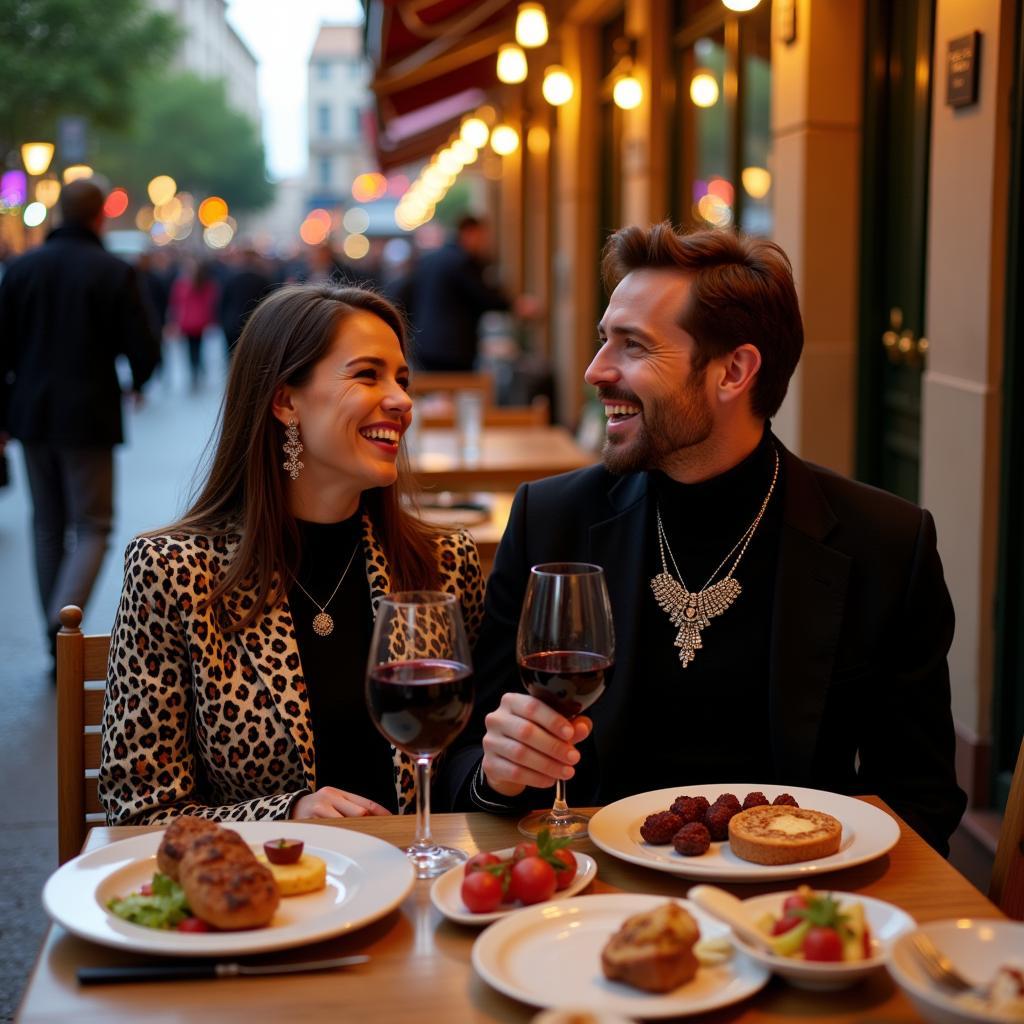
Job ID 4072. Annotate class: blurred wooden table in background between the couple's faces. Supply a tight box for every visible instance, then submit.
[413,427,597,493]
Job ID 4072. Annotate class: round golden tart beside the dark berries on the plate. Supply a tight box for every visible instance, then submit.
[729,804,843,864]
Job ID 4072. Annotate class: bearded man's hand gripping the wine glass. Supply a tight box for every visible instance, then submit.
[483,693,594,797]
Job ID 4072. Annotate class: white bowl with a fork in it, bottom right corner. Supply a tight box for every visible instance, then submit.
[886,918,1024,1024]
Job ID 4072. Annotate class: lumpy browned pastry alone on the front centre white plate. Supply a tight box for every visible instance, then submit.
[601,903,700,992]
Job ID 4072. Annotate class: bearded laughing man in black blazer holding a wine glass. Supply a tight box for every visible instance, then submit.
[446,224,966,852]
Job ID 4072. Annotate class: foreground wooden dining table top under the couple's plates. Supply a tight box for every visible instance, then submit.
[18,798,1002,1024]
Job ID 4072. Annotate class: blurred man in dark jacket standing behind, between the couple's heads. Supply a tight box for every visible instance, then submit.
[404,215,516,371]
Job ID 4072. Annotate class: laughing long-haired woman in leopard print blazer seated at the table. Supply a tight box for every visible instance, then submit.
[99,286,483,824]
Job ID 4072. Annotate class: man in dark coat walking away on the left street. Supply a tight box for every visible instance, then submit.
[0,180,160,651]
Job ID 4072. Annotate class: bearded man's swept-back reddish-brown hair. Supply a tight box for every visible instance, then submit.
[601,221,804,419]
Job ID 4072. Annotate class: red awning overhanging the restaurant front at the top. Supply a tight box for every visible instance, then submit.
[365,0,515,166]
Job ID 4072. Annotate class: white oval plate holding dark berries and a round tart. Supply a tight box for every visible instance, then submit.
[590,782,899,882]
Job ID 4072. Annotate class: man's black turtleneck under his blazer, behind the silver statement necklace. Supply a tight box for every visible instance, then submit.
[602,430,782,799]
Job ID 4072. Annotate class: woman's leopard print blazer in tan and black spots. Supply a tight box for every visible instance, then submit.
[98,515,483,824]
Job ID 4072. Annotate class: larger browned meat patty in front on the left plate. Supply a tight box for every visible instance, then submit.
[183,857,281,931]
